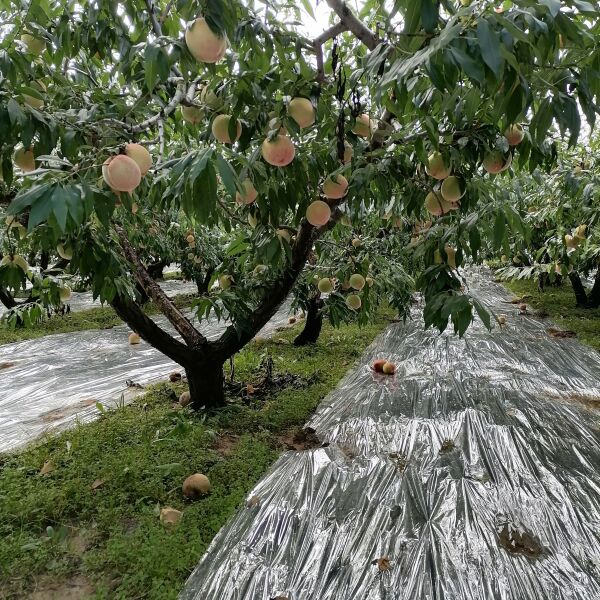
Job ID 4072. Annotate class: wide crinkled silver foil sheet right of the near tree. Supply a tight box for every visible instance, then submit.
[181,271,600,600]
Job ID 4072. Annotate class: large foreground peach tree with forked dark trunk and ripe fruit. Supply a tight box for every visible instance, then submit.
[0,0,600,408]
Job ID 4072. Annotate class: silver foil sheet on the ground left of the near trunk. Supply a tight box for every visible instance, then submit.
[0,292,291,452]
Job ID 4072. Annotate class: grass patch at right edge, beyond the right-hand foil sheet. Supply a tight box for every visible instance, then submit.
[504,280,600,351]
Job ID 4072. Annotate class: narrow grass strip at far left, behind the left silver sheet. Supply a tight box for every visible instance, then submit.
[0,294,192,346]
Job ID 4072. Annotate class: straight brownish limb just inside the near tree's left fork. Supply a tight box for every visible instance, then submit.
[114,223,208,348]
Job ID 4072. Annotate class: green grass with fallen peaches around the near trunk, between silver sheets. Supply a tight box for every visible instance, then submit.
[0,311,392,600]
